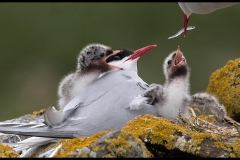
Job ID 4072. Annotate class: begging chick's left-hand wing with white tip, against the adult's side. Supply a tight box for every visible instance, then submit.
[129,83,163,110]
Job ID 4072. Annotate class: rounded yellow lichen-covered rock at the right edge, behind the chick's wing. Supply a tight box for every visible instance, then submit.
[207,58,240,119]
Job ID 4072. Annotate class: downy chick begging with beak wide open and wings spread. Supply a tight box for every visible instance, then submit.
[131,47,226,120]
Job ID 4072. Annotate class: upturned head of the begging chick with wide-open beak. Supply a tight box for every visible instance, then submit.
[163,47,190,81]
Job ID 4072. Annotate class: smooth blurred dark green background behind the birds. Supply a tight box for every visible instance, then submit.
[0,2,240,121]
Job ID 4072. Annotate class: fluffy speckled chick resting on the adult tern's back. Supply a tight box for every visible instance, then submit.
[58,44,120,109]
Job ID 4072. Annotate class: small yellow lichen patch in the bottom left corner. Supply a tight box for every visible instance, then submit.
[0,143,20,158]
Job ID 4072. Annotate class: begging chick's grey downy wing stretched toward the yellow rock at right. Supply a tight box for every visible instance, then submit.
[188,93,227,120]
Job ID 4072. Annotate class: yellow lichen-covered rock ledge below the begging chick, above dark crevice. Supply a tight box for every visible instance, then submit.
[122,114,240,158]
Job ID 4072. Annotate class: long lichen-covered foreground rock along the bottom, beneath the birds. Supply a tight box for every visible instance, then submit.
[0,110,240,158]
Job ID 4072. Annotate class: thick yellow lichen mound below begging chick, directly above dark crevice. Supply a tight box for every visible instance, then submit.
[122,114,187,149]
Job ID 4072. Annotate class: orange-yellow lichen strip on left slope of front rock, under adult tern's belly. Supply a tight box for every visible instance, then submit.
[54,130,109,158]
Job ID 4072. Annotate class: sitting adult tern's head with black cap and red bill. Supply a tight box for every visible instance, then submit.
[106,45,156,71]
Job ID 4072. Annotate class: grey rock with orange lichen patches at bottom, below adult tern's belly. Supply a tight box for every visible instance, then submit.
[30,130,153,158]
